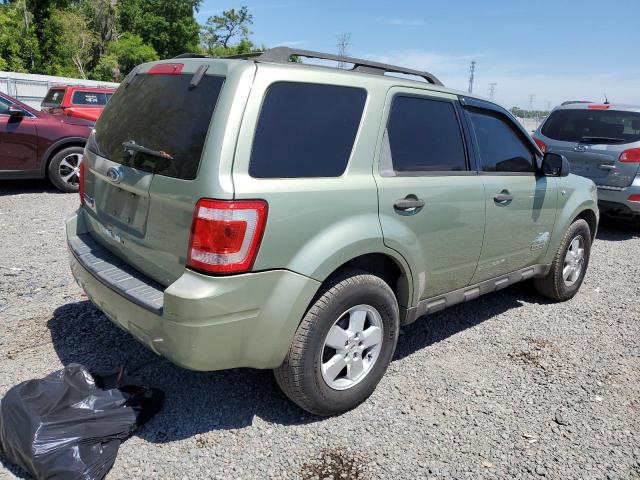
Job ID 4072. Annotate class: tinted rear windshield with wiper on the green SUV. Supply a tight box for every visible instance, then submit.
[95,74,224,180]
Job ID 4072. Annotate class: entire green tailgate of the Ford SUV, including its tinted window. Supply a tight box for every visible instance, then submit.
[84,60,230,285]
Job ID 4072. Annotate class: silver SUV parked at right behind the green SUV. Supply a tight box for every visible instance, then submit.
[533,102,640,218]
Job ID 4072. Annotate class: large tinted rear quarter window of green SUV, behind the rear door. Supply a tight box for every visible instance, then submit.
[249,82,367,178]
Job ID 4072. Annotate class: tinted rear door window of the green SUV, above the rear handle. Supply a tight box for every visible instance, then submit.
[387,96,466,173]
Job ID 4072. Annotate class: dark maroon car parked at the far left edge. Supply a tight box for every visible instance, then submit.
[0,93,94,192]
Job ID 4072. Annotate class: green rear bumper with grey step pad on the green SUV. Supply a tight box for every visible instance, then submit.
[67,211,320,370]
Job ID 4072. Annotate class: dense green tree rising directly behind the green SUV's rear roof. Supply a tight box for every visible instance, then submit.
[117,0,202,58]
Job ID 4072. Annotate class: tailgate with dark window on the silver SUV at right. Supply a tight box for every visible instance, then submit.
[541,105,640,188]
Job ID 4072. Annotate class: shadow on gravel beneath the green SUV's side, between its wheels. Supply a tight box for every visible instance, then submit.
[394,282,552,360]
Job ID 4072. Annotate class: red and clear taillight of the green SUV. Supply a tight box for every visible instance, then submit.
[187,198,267,273]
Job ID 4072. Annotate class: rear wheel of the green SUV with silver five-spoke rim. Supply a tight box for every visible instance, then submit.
[274,270,399,416]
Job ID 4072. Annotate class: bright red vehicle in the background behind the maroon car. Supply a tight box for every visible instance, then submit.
[40,85,116,122]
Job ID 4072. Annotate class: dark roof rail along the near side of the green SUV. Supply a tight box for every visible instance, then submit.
[251,47,444,86]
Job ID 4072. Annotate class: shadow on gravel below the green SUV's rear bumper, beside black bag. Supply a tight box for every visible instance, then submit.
[47,301,320,443]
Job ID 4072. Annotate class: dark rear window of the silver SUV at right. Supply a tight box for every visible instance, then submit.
[542,110,640,143]
